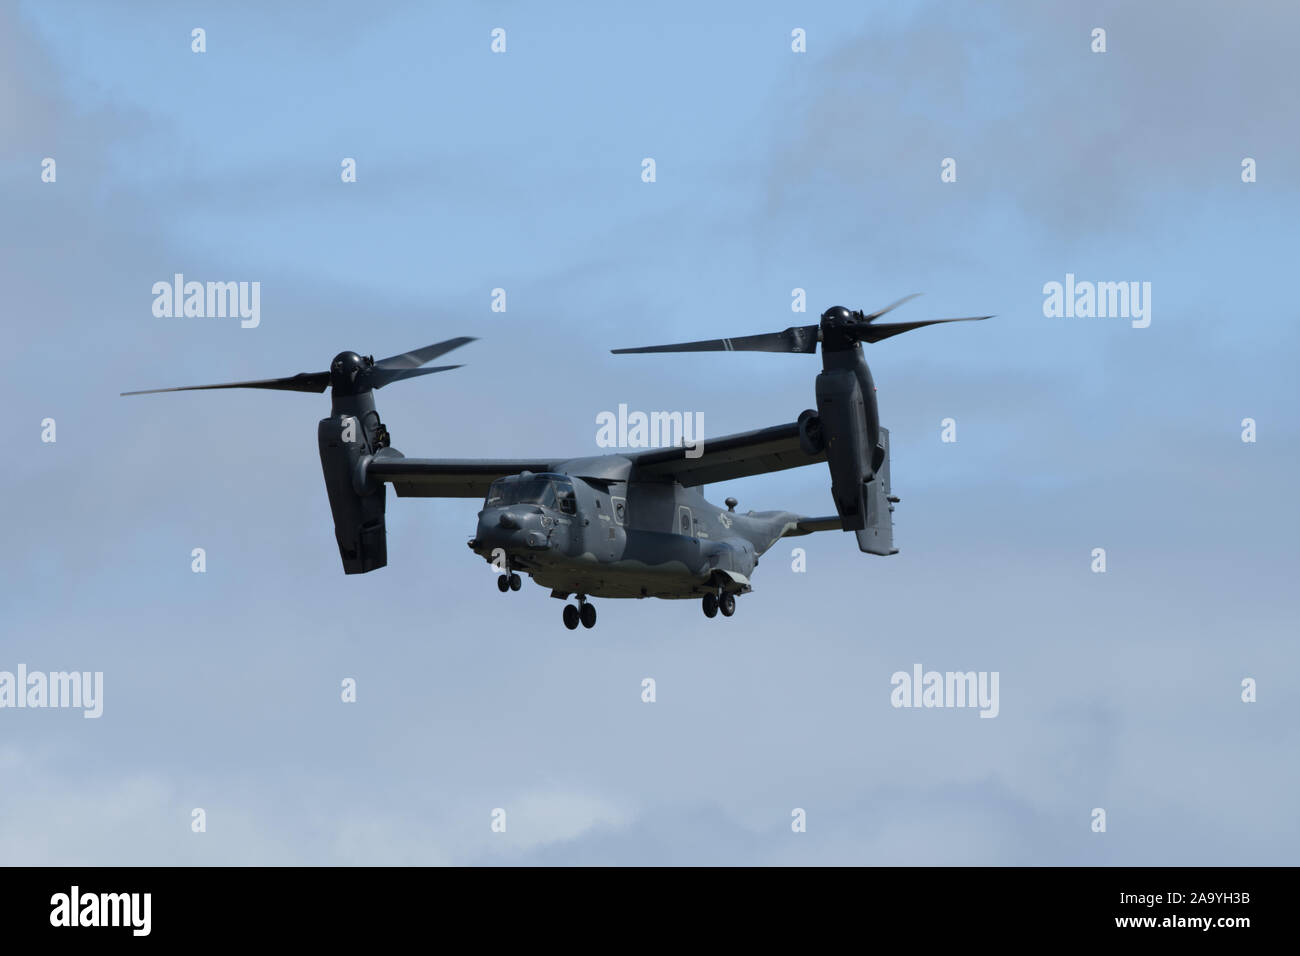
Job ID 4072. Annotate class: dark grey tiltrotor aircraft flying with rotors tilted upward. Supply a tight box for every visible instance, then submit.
[122,295,991,630]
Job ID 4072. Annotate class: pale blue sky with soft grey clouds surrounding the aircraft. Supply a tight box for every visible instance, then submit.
[0,3,1300,864]
